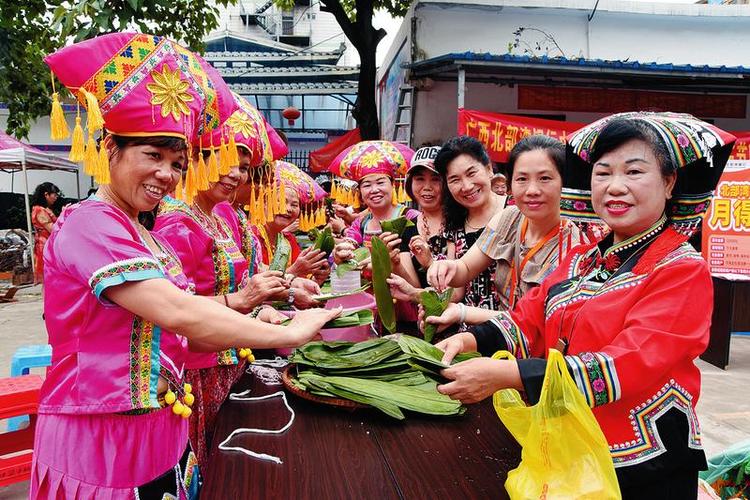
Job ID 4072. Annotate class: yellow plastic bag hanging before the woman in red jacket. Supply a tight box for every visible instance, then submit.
[492,349,622,500]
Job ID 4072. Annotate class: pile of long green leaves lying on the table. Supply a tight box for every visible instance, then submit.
[289,335,479,420]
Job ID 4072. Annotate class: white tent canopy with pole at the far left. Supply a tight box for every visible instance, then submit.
[0,132,81,268]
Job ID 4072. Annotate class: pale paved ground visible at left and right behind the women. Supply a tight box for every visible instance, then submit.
[0,287,750,500]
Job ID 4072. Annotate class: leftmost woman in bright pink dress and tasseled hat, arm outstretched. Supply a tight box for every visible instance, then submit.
[30,33,336,500]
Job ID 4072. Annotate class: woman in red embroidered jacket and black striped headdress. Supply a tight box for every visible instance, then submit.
[427,113,734,499]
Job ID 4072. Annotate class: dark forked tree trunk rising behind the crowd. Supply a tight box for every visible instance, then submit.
[275,0,411,140]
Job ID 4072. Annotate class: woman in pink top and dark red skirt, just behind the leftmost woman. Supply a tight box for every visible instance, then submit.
[154,119,289,470]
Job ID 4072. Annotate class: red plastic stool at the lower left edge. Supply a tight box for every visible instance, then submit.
[0,375,42,486]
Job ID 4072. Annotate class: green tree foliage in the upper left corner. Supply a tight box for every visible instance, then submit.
[0,0,232,138]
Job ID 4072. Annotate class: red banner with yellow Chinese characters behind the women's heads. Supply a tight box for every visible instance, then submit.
[458,109,585,163]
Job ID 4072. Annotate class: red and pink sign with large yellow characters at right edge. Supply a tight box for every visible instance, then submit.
[702,160,750,279]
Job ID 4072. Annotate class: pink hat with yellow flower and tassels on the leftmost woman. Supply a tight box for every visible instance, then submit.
[45,33,231,187]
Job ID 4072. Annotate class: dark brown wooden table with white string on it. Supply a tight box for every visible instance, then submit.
[201,362,520,499]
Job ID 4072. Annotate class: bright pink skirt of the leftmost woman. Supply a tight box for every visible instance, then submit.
[29,408,198,500]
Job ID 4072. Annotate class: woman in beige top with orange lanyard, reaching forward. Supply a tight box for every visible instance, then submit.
[428,135,581,319]
